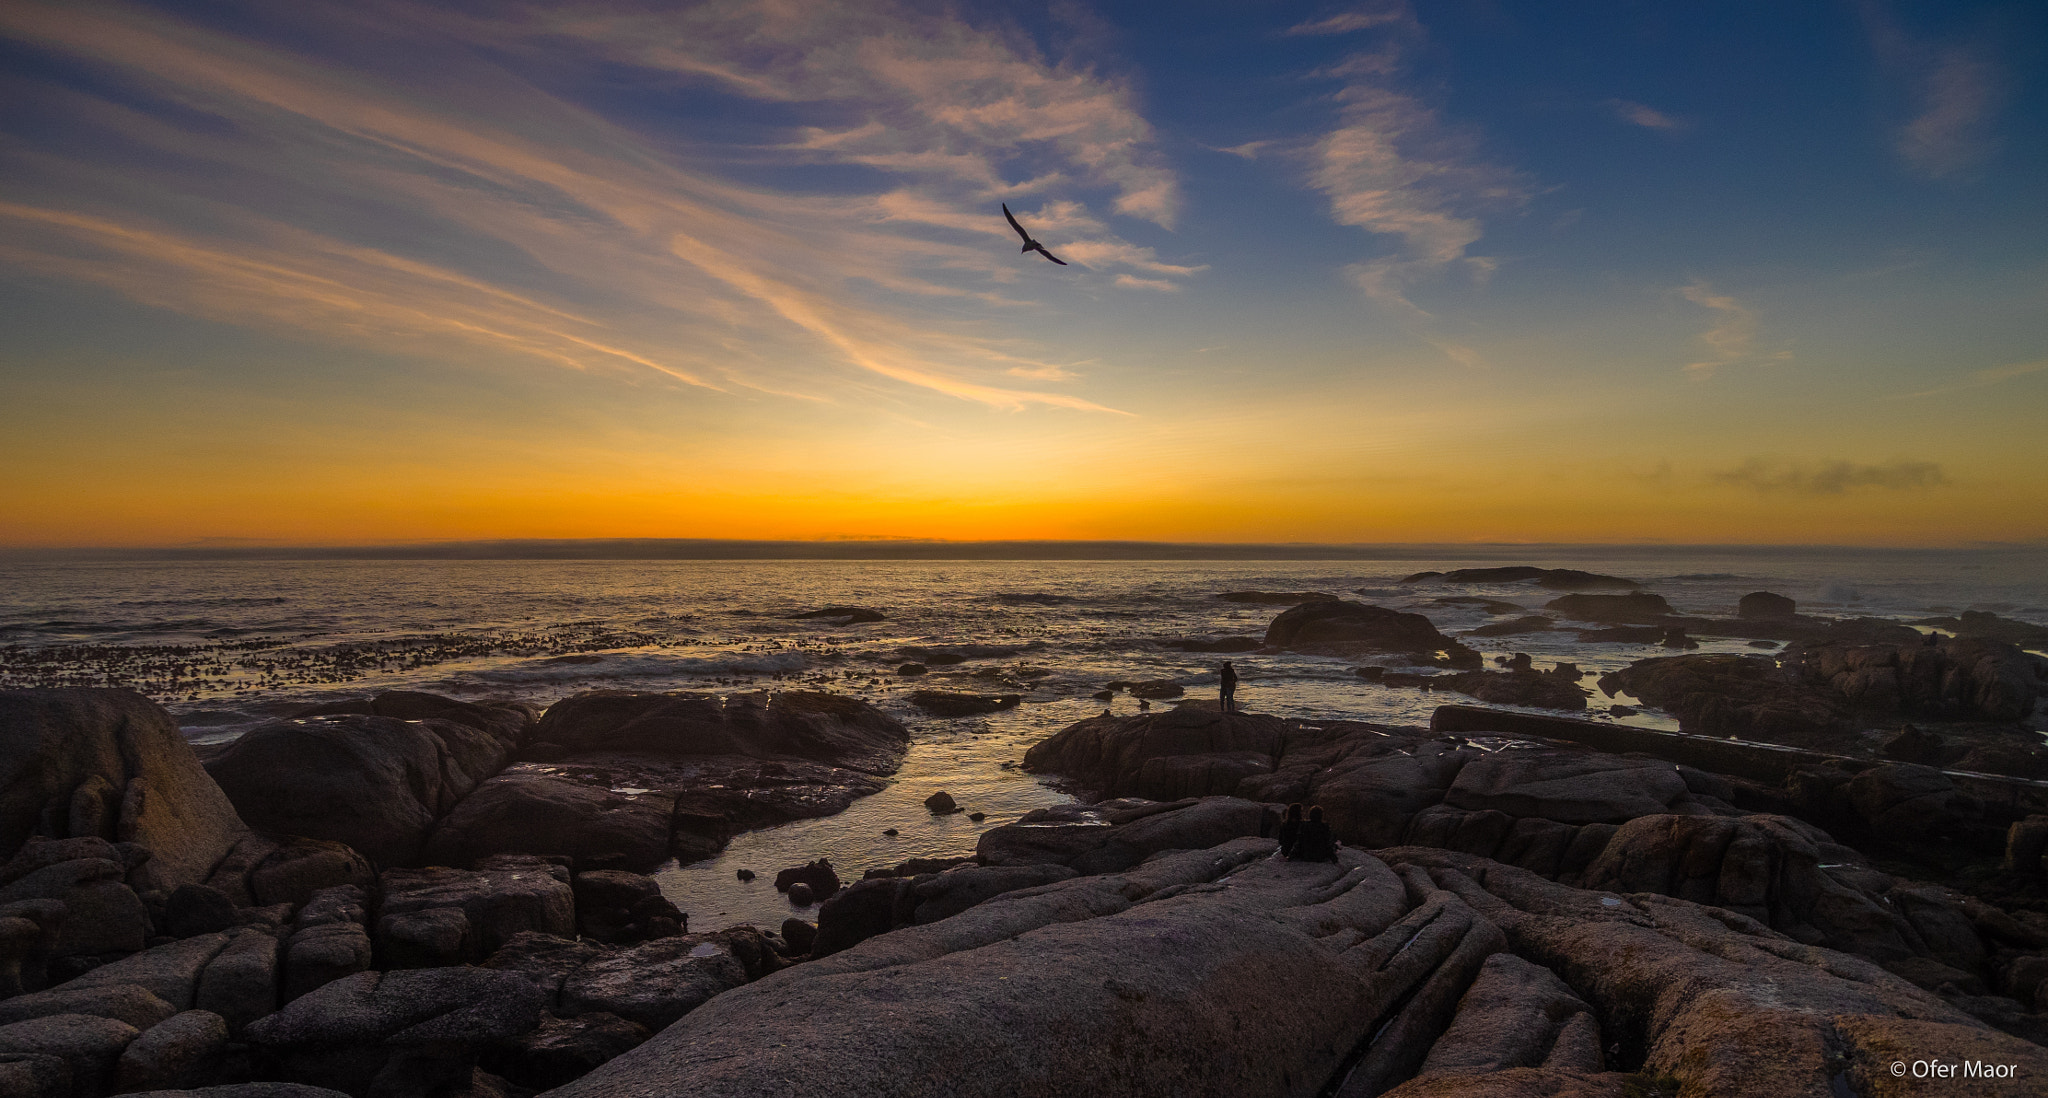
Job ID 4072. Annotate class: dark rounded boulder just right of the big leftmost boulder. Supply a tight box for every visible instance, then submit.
[207,713,512,867]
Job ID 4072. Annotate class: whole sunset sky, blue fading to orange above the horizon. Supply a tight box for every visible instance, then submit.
[0,0,2048,547]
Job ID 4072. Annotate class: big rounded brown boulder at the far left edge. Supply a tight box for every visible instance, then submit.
[0,688,248,891]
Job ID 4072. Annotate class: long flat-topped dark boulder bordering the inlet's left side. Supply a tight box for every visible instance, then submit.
[535,690,909,774]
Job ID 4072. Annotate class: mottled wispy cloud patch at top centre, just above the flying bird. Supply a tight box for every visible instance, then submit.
[493,0,1180,227]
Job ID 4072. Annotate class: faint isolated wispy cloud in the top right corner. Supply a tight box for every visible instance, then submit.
[1862,0,2003,178]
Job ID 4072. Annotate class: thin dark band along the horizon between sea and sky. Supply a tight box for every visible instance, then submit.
[0,537,2048,563]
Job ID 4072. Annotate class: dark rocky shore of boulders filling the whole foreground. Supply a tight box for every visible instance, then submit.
[0,569,2048,1098]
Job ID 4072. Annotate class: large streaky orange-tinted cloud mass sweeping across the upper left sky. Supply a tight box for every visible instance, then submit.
[0,2,1171,412]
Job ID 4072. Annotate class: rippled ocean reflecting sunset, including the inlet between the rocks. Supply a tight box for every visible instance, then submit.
[0,551,2048,930]
